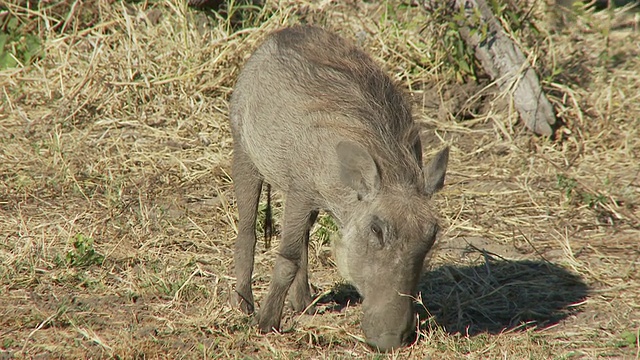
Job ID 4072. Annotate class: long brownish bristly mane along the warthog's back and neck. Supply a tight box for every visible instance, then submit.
[274,26,423,191]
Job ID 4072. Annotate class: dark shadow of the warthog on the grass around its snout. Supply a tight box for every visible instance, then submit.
[319,253,589,336]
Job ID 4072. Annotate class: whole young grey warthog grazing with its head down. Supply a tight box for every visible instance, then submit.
[230,26,448,350]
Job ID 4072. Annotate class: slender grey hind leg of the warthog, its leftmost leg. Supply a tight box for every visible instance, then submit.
[232,142,262,314]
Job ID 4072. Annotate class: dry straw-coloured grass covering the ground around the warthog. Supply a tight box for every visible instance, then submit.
[0,0,640,359]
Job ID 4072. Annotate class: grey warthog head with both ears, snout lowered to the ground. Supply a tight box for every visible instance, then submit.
[334,143,448,351]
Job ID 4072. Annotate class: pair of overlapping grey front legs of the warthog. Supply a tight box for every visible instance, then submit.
[259,196,317,332]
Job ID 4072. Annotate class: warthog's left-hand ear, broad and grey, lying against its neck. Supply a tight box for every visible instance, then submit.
[336,141,380,198]
